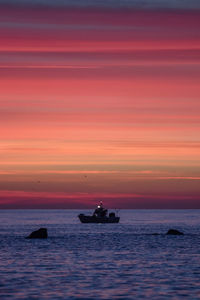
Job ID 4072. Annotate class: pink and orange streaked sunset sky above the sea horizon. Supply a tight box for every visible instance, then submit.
[0,0,200,209]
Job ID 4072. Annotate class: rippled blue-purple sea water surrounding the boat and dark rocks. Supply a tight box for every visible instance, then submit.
[0,210,200,299]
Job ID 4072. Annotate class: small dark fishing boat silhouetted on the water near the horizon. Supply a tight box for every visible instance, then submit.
[78,202,120,223]
